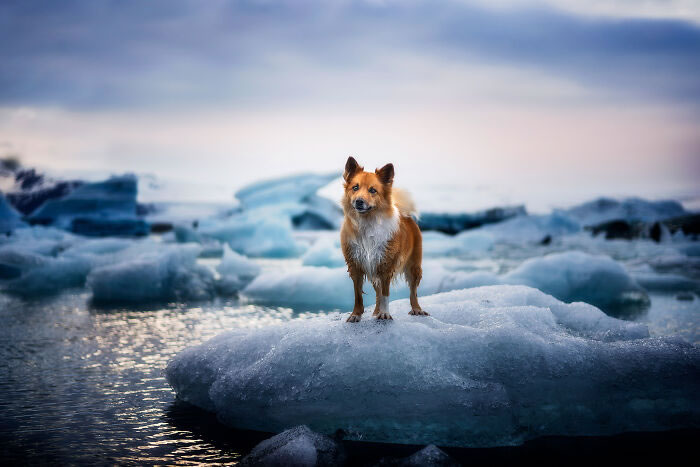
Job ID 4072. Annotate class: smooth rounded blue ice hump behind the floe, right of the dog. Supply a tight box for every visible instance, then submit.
[504,251,649,311]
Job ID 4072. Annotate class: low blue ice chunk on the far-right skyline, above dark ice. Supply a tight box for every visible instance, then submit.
[566,198,686,226]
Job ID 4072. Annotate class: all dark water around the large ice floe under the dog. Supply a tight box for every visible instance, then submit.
[0,291,698,464]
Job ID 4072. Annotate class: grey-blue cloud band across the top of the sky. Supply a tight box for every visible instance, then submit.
[0,0,700,109]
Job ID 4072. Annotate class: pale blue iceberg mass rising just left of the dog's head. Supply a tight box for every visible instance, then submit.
[174,174,342,258]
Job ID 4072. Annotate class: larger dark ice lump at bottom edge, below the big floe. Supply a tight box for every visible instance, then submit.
[240,425,346,467]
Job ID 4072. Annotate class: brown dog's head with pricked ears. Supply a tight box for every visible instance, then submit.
[343,157,394,216]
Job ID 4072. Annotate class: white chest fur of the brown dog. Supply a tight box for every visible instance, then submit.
[350,207,399,280]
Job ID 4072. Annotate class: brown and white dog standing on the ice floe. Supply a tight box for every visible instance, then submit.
[340,157,428,323]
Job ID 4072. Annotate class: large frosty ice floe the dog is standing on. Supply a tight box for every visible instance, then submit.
[166,285,700,446]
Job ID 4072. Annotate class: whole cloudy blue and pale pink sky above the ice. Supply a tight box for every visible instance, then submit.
[0,0,700,210]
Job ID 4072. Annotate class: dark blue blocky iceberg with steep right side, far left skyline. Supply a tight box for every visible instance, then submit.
[29,174,148,236]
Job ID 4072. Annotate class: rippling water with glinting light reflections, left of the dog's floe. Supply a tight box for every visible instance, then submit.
[0,294,294,464]
